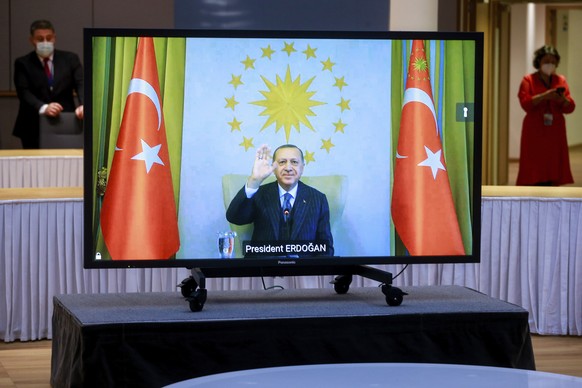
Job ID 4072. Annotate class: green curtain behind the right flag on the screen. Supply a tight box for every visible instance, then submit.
[391,40,479,255]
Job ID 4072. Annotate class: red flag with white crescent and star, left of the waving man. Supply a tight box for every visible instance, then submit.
[101,37,180,260]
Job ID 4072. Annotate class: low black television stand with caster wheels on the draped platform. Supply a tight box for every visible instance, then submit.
[178,265,408,312]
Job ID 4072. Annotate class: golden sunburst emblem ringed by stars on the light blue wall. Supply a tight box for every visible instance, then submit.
[224,41,351,163]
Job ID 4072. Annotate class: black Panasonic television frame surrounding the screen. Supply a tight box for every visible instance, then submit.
[83,28,484,270]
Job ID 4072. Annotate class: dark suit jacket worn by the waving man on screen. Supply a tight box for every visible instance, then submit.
[226,181,333,255]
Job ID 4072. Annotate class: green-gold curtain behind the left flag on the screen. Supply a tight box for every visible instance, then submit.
[91,37,186,252]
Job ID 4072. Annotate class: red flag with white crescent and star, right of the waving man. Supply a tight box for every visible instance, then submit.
[391,40,465,255]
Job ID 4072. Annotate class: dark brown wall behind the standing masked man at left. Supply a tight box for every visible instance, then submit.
[0,0,174,149]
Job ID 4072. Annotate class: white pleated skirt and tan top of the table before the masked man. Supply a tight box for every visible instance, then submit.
[0,150,83,188]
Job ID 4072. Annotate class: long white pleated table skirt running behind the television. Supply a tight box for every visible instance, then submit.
[0,189,582,341]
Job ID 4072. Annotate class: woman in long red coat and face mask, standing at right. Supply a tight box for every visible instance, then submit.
[516,46,576,186]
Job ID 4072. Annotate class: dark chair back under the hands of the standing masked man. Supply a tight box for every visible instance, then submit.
[39,112,83,148]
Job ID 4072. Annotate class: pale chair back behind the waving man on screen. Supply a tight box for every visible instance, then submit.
[222,174,348,257]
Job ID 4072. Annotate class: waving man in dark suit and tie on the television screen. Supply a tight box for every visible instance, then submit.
[226,144,334,255]
